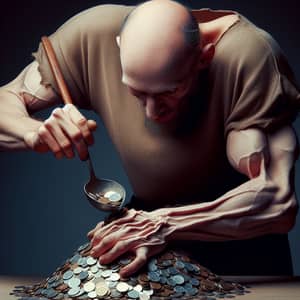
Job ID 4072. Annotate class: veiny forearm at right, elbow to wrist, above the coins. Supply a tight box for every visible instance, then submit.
[157,177,297,241]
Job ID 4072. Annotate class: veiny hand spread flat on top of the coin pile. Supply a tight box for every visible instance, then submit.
[88,209,172,277]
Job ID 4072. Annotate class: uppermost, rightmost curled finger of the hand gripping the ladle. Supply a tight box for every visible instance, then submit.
[63,104,94,145]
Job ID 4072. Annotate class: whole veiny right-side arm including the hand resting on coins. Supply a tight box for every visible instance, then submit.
[88,126,299,276]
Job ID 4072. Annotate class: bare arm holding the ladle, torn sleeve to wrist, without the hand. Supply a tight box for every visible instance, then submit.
[0,62,61,150]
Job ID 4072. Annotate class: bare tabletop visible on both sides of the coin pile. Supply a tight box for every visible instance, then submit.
[0,275,300,300]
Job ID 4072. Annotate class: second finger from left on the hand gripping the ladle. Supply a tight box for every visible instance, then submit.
[44,116,74,158]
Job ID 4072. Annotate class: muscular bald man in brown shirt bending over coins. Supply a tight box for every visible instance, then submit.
[0,0,300,276]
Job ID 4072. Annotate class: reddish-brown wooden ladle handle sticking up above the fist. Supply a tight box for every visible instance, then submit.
[42,36,73,104]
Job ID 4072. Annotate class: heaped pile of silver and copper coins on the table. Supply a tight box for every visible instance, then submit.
[11,243,249,300]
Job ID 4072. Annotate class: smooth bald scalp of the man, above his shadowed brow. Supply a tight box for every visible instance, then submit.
[120,0,200,91]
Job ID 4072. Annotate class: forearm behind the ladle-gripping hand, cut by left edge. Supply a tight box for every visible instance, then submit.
[0,89,42,151]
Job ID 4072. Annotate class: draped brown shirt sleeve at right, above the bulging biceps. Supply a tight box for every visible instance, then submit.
[224,24,300,137]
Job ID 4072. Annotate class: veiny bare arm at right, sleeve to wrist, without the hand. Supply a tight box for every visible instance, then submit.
[166,126,298,241]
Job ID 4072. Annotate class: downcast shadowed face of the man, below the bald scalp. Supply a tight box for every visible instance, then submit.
[122,59,198,124]
